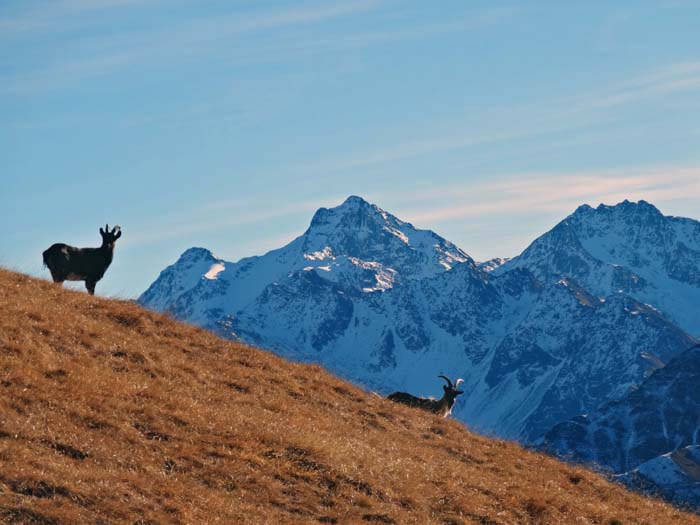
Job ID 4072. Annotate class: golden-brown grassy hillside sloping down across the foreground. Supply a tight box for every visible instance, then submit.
[0,270,700,525]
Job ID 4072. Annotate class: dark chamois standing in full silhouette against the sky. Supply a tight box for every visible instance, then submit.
[43,224,122,295]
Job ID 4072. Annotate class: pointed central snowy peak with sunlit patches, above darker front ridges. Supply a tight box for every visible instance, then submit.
[139,196,475,323]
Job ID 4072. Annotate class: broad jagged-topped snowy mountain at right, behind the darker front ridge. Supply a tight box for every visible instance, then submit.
[494,201,700,336]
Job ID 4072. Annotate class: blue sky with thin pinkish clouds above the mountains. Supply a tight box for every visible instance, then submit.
[0,0,700,297]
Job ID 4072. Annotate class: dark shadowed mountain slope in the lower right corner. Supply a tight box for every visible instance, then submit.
[543,345,700,506]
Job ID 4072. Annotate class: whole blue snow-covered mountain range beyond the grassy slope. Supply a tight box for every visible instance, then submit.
[139,197,700,508]
